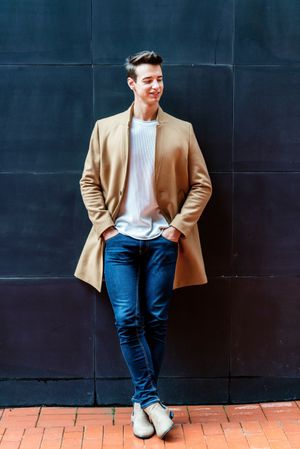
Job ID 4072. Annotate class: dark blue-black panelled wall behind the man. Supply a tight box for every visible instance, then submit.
[0,0,300,406]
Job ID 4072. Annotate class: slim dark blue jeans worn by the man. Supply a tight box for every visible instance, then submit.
[104,233,178,408]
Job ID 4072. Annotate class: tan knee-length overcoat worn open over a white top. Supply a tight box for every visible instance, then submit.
[74,103,212,292]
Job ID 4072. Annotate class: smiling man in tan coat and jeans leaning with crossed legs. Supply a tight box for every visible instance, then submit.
[75,51,212,438]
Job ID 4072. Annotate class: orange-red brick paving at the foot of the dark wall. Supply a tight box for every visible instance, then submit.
[0,401,300,449]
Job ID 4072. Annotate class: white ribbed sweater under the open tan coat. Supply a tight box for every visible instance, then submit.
[115,117,169,240]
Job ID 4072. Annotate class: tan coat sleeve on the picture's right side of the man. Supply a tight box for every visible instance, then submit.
[170,124,212,238]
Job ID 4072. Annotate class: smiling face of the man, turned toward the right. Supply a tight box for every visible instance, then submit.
[127,64,164,106]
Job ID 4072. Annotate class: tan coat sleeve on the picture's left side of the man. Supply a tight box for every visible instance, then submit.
[79,120,114,238]
